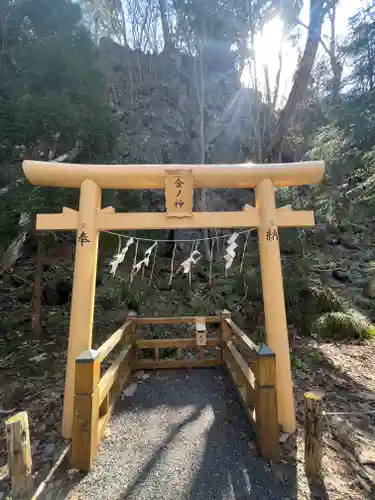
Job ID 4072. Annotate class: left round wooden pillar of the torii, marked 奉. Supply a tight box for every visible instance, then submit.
[62,179,101,439]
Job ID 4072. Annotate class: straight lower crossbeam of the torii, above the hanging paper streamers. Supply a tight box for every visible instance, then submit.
[36,208,315,231]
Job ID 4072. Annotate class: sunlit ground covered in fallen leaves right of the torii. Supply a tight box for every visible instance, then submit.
[294,339,375,500]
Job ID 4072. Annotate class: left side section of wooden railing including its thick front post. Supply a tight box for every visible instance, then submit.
[72,317,135,472]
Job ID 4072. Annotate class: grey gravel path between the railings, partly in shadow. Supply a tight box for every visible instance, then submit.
[62,368,296,500]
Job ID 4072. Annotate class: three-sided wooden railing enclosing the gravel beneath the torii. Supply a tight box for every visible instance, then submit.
[72,312,280,471]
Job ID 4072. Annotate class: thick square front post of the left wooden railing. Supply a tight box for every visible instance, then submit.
[72,349,100,472]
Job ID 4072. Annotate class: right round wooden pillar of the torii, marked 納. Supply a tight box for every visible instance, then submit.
[256,179,296,434]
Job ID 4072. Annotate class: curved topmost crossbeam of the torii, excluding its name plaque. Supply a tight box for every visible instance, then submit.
[23,161,324,189]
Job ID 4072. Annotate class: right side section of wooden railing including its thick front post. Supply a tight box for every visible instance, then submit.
[221,313,280,460]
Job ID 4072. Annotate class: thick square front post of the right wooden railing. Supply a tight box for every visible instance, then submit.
[254,345,280,460]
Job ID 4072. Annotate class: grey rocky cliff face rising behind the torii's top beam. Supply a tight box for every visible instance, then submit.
[98,39,266,210]
